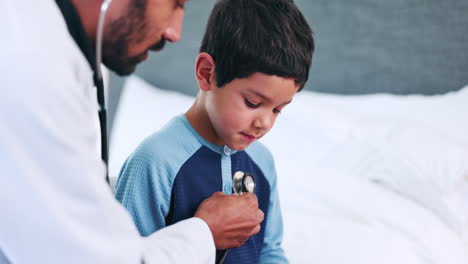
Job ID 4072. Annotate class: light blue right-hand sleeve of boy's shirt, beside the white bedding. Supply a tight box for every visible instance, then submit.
[247,143,289,264]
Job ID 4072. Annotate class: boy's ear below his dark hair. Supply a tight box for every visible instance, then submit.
[195,52,216,91]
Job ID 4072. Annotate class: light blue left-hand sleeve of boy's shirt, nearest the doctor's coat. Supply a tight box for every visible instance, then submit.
[115,115,201,236]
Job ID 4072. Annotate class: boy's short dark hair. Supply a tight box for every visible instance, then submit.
[200,0,314,90]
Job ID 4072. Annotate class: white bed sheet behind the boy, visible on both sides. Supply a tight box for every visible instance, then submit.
[110,77,468,264]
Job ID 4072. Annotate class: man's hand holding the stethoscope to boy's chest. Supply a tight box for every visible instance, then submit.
[195,192,264,249]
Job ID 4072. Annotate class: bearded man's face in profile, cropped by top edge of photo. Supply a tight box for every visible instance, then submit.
[102,0,188,75]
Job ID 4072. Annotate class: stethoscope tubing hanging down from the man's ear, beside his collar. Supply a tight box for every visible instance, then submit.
[94,0,112,183]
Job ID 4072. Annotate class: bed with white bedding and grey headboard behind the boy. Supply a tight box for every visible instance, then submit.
[109,0,468,264]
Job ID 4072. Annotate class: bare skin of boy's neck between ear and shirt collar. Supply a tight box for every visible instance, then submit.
[185,95,224,146]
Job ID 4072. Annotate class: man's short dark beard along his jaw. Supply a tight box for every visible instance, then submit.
[102,0,147,76]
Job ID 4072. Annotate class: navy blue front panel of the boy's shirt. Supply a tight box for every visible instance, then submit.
[166,146,270,264]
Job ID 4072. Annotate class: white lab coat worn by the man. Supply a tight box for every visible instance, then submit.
[0,0,215,264]
